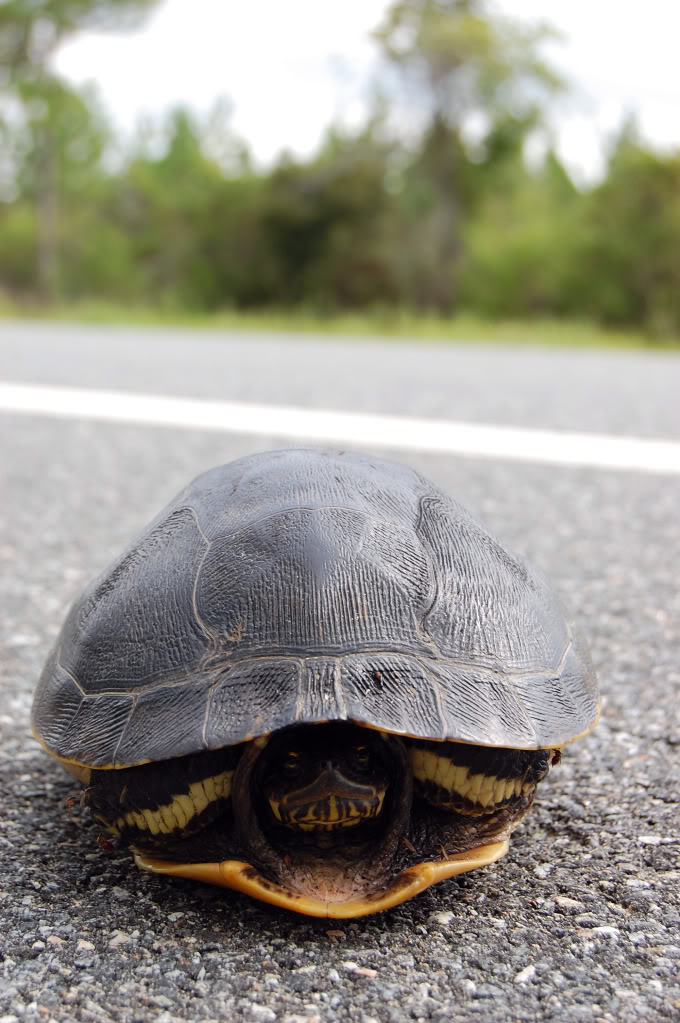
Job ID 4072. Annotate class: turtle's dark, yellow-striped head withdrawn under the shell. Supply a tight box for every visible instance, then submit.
[260,724,390,835]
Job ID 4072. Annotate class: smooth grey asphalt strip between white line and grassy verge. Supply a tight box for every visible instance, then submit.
[0,323,680,438]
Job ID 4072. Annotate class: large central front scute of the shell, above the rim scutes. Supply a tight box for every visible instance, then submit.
[196,507,430,659]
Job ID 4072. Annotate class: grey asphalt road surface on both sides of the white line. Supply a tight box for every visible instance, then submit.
[0,324,680,1023]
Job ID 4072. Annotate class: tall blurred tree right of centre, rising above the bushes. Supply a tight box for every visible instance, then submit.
[375,0,561,311]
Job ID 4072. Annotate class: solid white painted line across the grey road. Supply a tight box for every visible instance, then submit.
[0,384,680,476]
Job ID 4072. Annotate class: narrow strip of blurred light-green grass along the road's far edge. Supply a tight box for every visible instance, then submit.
[0,299,680,349]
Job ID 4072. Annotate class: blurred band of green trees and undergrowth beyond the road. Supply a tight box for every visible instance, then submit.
[0,0,680,338]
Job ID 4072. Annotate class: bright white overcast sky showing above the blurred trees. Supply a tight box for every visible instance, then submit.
[56,0,680,178]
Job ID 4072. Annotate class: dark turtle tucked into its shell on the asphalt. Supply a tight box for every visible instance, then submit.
[32,447,599,919]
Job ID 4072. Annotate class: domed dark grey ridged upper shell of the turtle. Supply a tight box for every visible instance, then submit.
[33,448,598,767]
